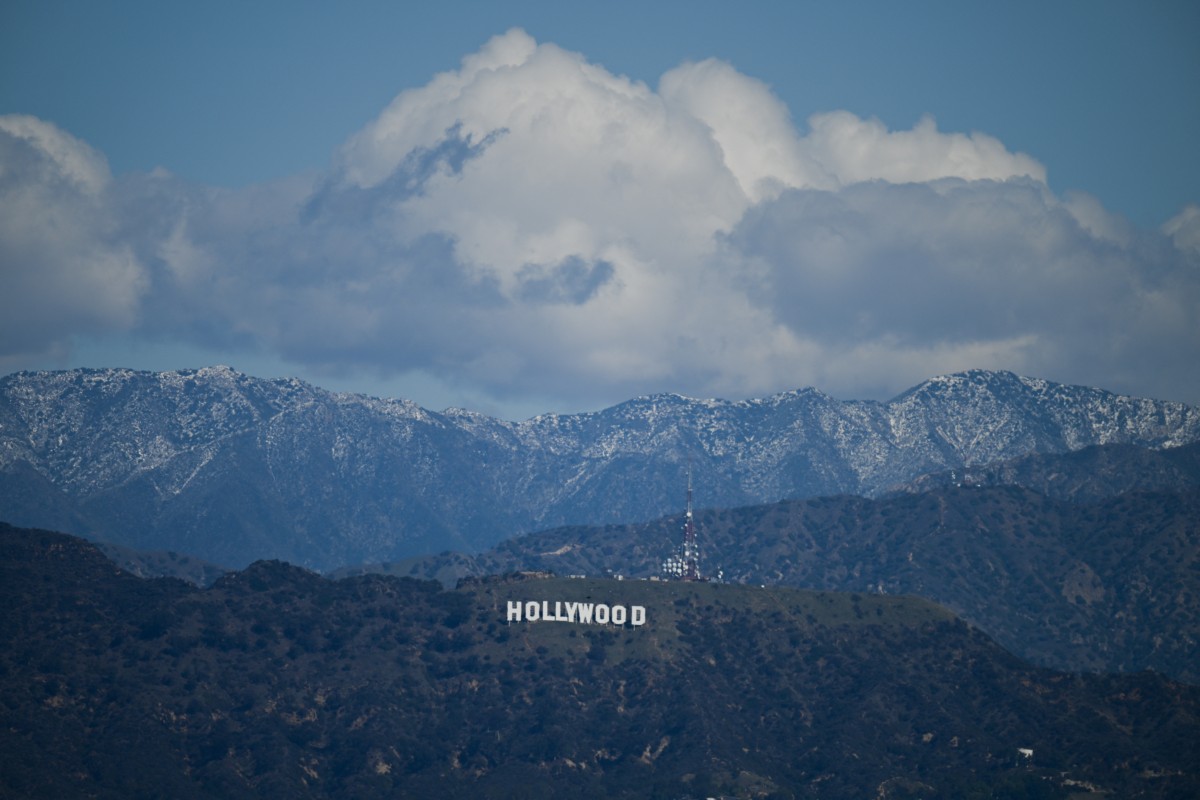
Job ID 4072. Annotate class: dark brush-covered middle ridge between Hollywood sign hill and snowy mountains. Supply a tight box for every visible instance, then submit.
[373,487,1200,682]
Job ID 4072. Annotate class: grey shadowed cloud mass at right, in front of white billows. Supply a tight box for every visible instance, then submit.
[724,179,1200,395]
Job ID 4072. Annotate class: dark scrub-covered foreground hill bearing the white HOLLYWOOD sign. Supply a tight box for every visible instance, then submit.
[0,527,1200,798]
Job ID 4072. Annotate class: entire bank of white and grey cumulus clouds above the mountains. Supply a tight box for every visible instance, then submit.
[0,30,1200,407]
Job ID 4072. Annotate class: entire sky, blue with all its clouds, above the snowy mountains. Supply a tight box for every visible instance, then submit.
[0,1,1200,416]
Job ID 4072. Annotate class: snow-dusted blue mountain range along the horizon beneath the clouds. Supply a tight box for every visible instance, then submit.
[0,367,1200,569]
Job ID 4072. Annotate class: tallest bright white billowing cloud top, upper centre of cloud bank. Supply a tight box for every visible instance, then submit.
[338,31,748,296]
